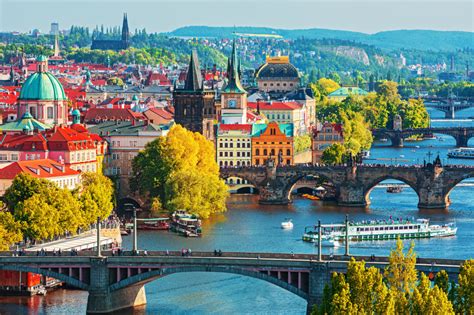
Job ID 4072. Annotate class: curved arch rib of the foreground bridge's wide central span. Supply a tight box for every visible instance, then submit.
[109,265,309,300]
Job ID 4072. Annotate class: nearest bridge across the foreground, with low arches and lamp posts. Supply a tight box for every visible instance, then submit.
[0,252,462,313]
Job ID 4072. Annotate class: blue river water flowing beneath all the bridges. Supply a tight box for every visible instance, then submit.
[0,110,474,315]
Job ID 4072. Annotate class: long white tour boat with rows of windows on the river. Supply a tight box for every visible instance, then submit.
[303,219,457,244]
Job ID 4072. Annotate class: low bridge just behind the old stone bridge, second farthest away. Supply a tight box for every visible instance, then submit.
[372,127,474,147]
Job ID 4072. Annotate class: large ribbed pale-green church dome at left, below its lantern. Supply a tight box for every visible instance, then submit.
[19,72,67,101]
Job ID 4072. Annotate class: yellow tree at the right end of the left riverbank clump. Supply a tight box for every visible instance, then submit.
[75,173,114,224]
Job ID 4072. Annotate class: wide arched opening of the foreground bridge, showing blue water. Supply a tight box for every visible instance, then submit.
[114,267,308,314]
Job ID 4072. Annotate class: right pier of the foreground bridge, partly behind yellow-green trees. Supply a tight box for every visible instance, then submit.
[306,263,331,315]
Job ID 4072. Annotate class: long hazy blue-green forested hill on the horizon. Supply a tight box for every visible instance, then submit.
[167,26,474,51]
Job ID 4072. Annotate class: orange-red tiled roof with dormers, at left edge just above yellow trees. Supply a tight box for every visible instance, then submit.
[0,159,81,179]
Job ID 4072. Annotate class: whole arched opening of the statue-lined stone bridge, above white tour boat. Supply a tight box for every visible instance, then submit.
[364,177,419,210]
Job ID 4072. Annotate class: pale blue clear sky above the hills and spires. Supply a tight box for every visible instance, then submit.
[0,0,474,33]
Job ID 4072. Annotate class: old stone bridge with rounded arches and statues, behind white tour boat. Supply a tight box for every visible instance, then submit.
[220,163,474,209]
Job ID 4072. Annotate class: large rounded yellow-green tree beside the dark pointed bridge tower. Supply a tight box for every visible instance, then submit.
[131,125,228,218]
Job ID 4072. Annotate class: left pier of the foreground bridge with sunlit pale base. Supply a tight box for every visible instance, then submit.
[87,258,146,314]
